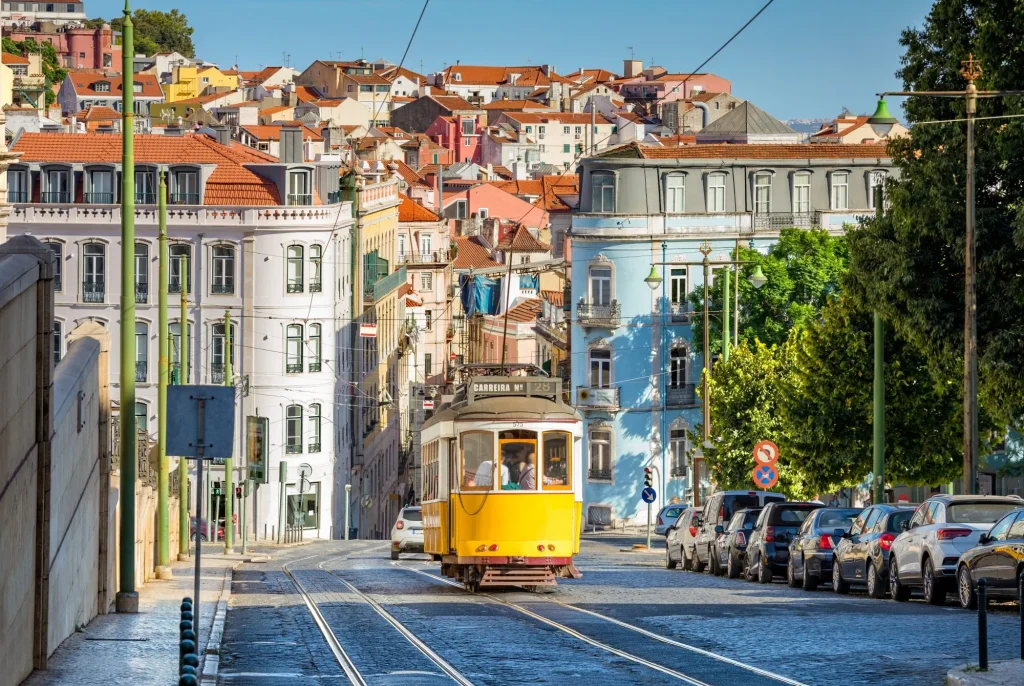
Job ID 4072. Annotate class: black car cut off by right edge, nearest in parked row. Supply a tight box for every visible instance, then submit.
[956,507,1024,610]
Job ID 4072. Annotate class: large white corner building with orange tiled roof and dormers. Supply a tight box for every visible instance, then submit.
[7,127,353,538]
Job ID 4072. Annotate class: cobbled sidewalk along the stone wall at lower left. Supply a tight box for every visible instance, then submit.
[23,544,240,686]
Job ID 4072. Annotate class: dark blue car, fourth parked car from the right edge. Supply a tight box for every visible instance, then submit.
[785,508,861,591]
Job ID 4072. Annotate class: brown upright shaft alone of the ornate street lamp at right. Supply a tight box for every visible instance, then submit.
[964,78,978,495]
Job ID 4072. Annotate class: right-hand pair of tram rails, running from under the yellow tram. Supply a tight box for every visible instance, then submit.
[391,562,806,686]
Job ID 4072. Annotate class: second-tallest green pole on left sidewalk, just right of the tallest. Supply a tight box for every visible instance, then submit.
[156,176,169,578]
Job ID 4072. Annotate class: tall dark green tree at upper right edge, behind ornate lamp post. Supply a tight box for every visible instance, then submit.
[850,0,1024,427]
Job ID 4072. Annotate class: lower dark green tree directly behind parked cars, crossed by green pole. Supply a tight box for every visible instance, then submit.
[782,296,963,492]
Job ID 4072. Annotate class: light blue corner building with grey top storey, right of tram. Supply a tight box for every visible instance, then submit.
[570,138,894,525]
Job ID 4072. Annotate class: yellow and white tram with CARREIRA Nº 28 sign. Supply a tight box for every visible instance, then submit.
[421,376,583,591]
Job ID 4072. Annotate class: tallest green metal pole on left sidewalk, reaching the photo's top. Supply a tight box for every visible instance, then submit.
[115,0,138,612]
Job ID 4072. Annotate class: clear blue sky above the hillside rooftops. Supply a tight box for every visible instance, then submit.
[94,0,932,119]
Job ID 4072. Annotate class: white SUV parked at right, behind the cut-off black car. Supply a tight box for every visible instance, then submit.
[889,495,1022,605]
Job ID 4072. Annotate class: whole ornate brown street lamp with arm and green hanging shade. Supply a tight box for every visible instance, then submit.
[867,54,1024,495]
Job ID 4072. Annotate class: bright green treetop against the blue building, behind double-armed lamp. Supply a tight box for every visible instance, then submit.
[689,228,849,355]
